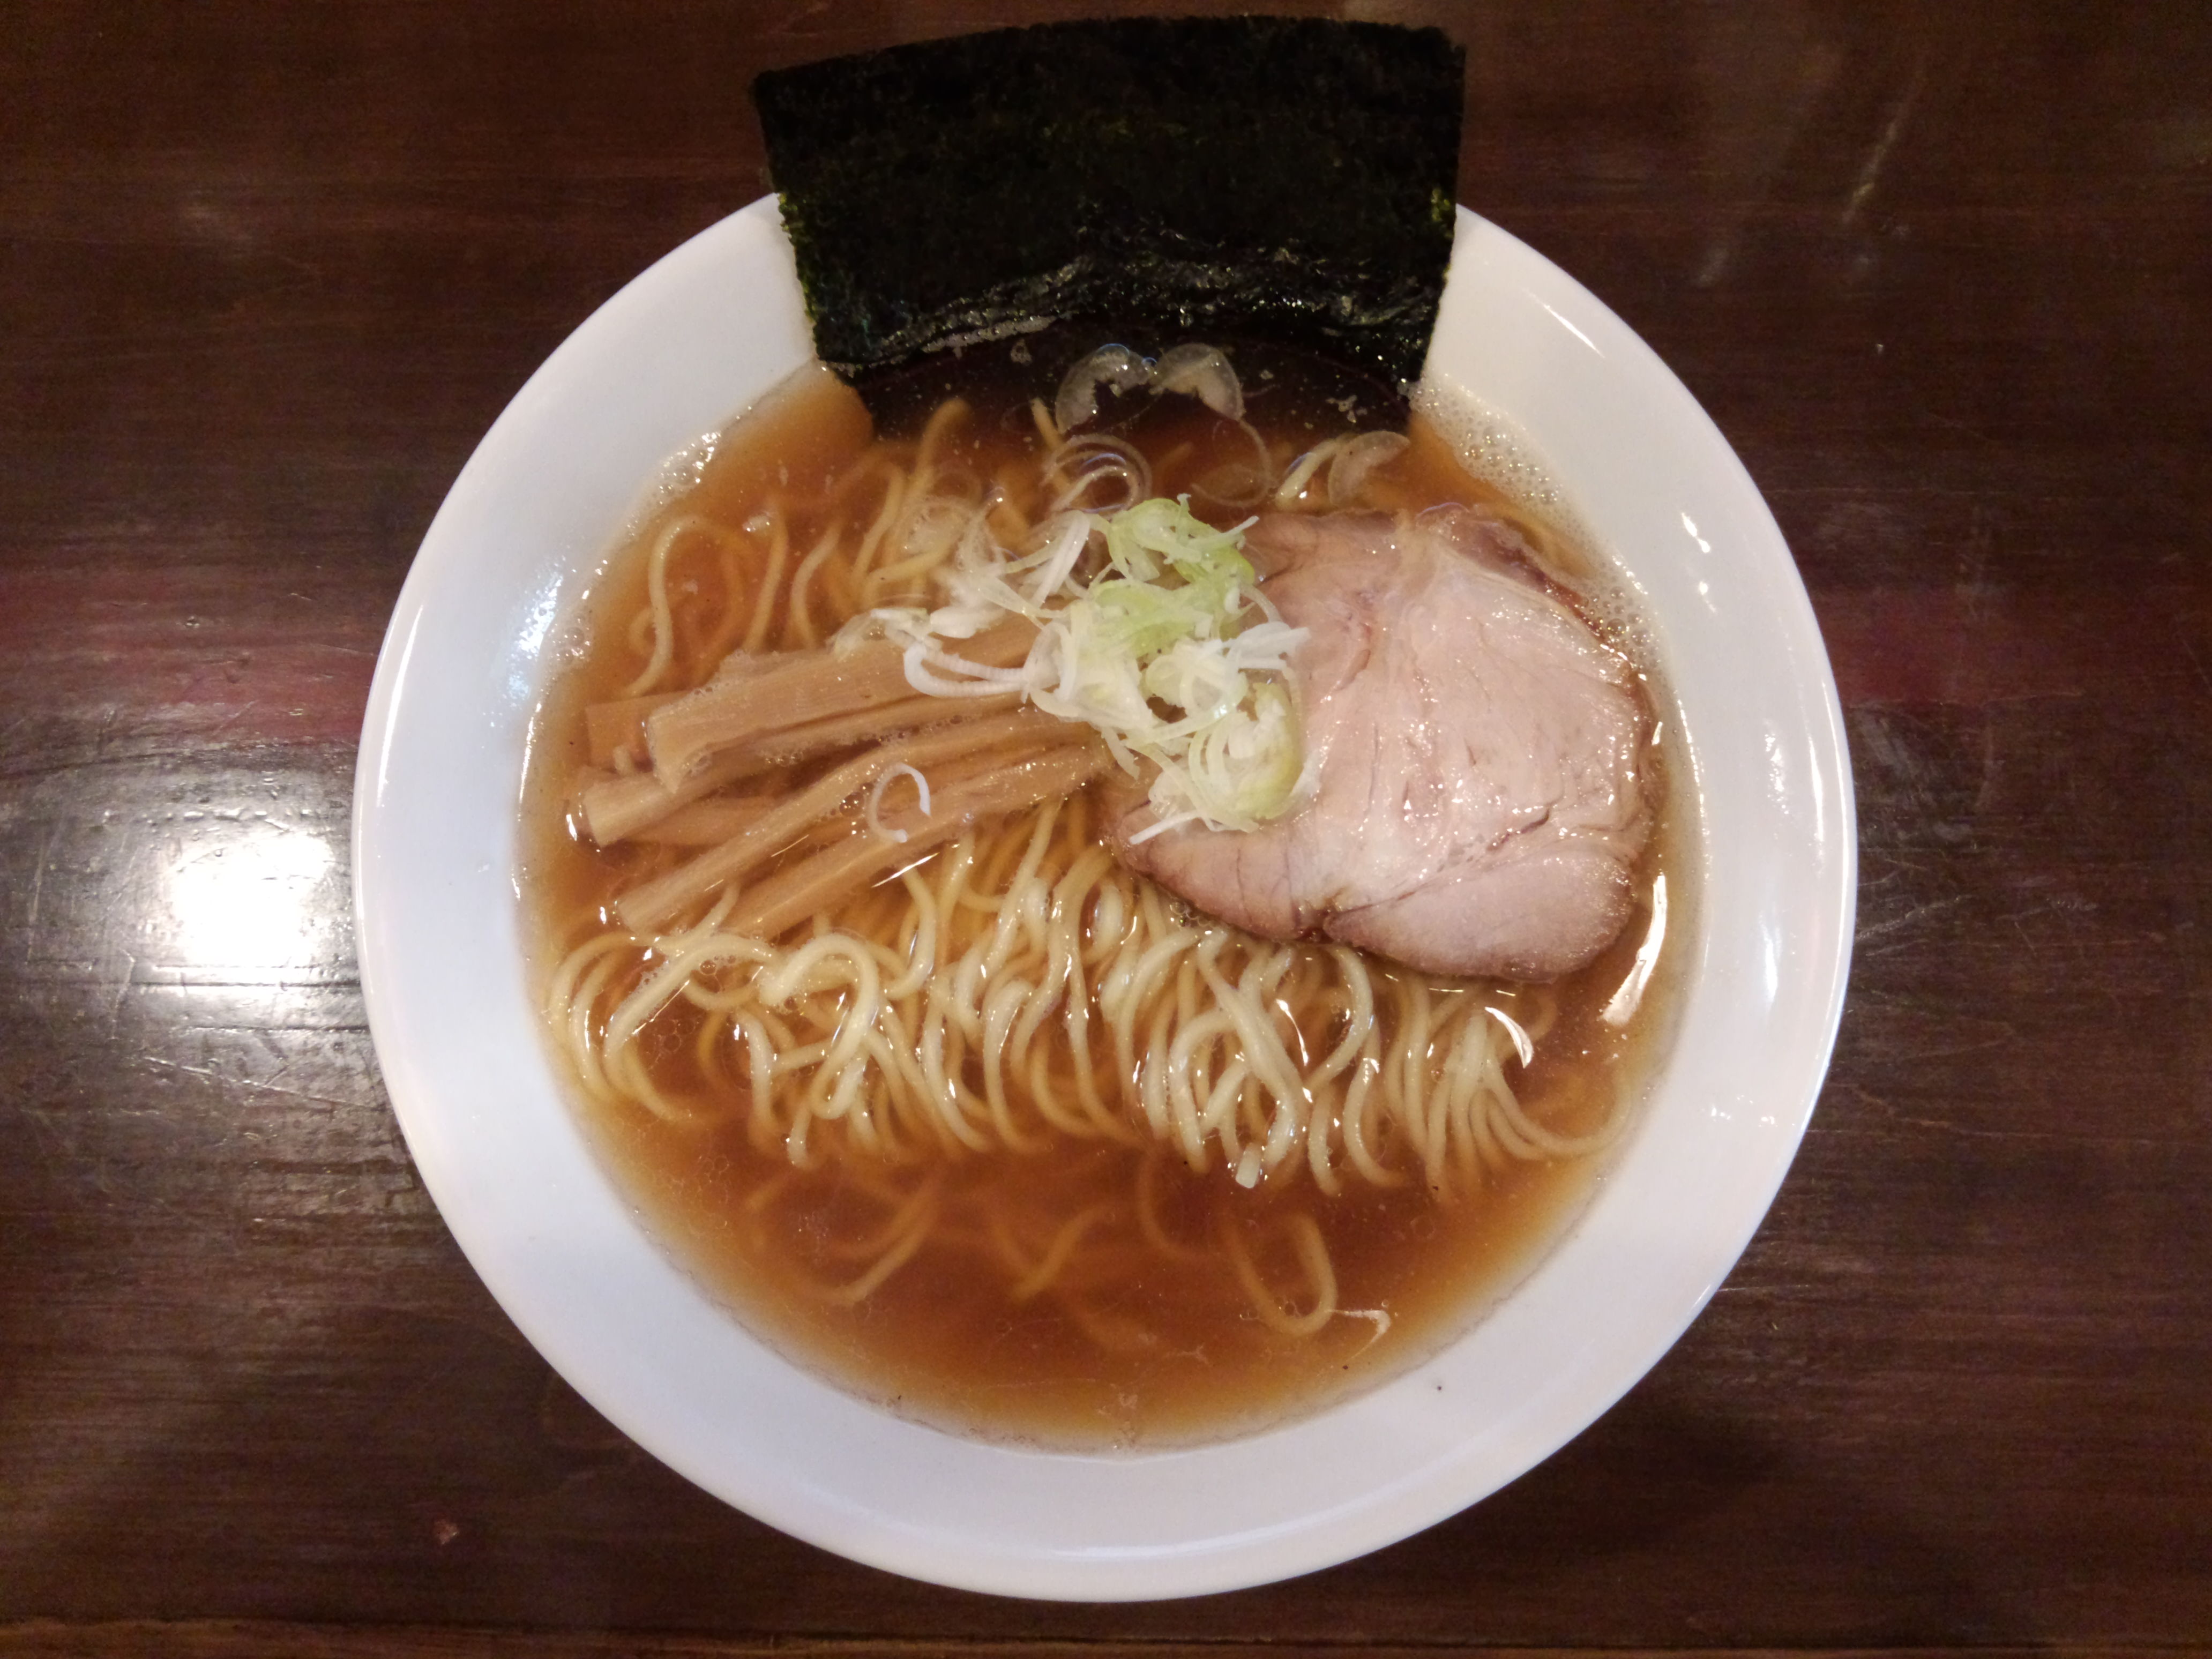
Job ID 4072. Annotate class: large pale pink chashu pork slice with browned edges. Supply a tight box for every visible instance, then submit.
[1112,509,1650,980]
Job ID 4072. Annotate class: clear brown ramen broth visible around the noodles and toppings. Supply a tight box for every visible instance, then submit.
[524,340,1690,1447]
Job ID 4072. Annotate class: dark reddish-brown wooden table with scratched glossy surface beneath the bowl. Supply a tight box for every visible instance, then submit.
[0,0,2212,1655]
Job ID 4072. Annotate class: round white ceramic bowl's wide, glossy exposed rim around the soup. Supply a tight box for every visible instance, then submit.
[354,201,1856,1600]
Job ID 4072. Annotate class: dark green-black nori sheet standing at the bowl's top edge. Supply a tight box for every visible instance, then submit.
[752,18,1464,380]
